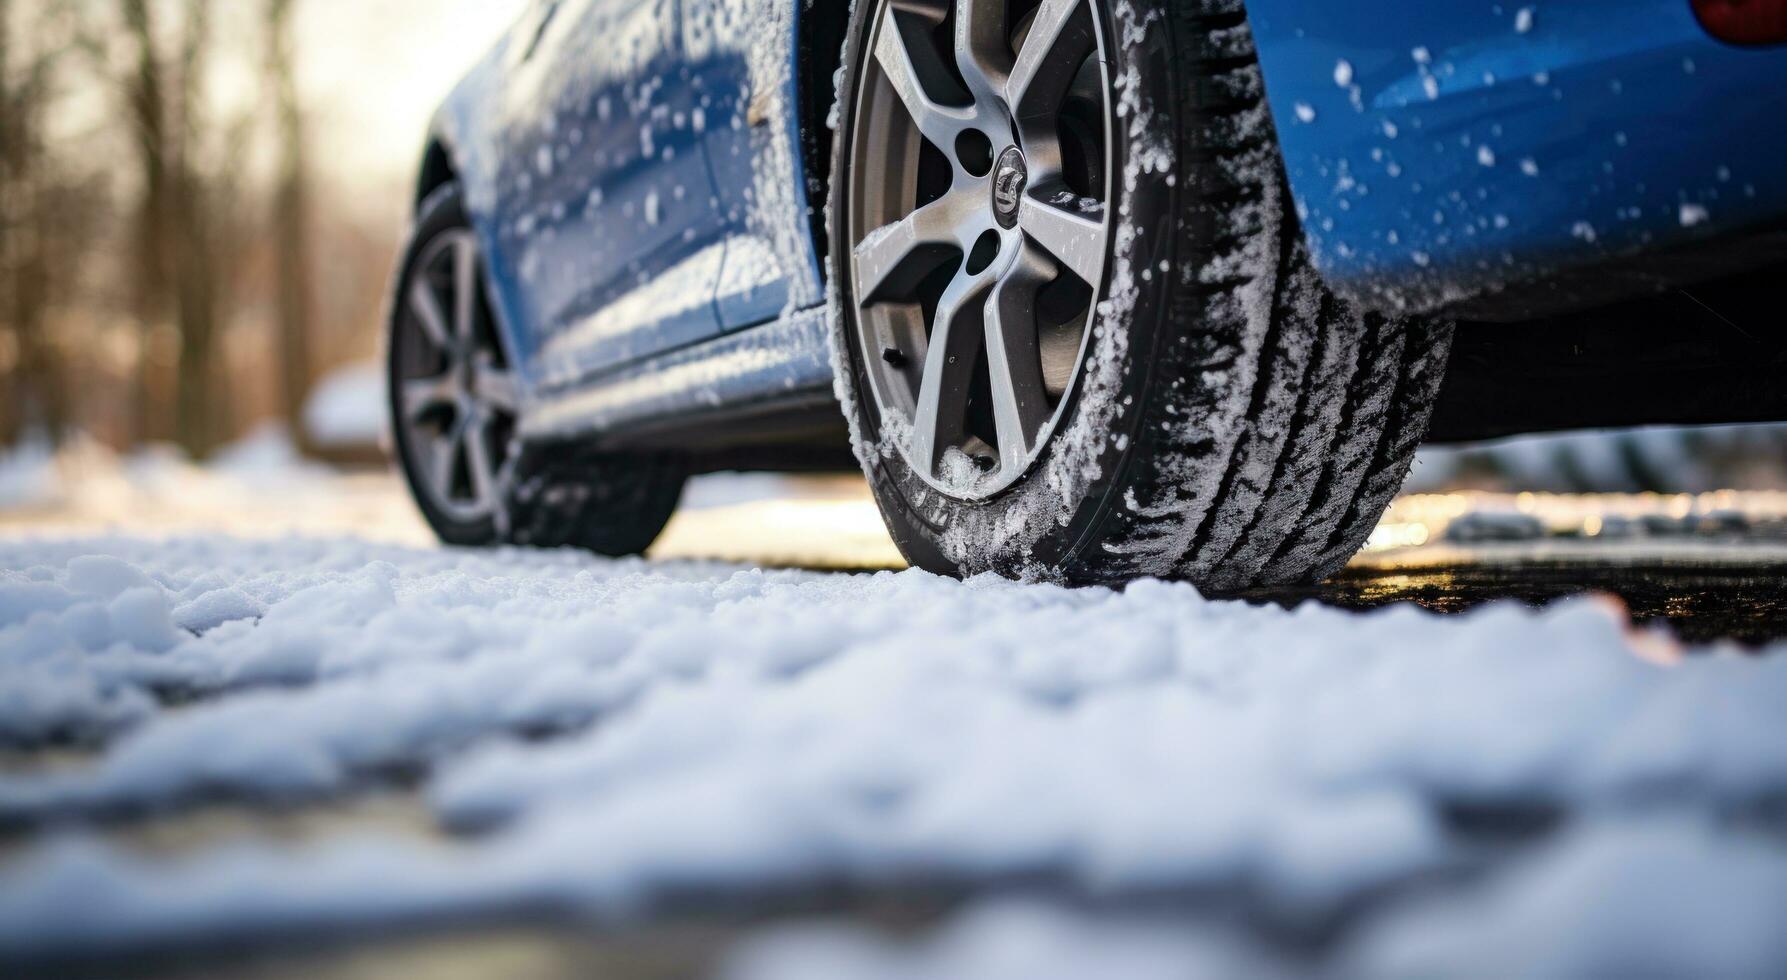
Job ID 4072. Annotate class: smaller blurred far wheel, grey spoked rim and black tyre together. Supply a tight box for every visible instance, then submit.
[388,184,684,556]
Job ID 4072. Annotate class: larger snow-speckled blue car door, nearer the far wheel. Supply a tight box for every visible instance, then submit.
[495,0,726,390]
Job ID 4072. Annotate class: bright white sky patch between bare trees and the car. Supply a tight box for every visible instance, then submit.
[297,0,529,188]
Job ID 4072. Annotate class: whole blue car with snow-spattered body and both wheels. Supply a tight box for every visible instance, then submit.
[388,0,1787,590]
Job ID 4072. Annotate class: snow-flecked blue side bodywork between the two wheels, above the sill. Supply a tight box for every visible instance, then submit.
[434,0,818,413]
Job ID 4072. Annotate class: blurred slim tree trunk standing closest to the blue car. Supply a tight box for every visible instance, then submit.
[266,0,315,454]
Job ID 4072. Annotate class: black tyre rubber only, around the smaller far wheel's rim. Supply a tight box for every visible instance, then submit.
[386,184,686,556]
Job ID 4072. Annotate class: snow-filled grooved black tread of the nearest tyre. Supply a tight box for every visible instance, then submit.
[1095,2,1451,590]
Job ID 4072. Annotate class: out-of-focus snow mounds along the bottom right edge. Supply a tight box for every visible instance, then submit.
[724,819,1787,980]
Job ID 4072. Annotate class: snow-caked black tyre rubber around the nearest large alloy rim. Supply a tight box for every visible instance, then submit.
[829,0,1451,590]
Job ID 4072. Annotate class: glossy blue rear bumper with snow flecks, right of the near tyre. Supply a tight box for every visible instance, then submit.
[1249,0,1787,308]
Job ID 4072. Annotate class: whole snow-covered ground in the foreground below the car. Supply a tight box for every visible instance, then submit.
[0,456,1787,978]
